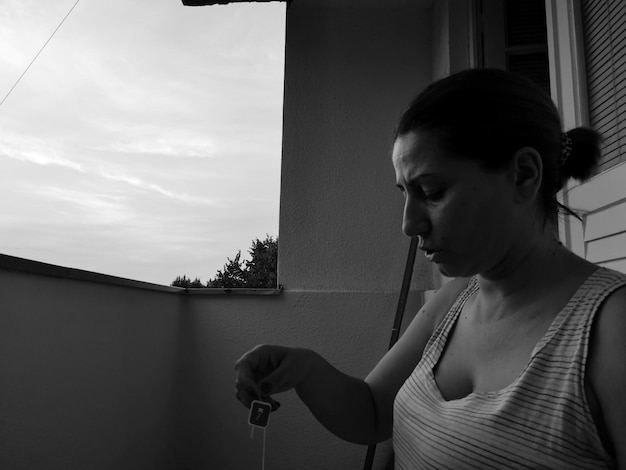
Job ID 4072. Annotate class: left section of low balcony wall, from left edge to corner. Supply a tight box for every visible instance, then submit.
[0,269,187,470]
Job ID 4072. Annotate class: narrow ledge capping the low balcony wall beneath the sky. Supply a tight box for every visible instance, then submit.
[0,254,282,295]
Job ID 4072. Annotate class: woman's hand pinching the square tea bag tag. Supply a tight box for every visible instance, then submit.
[235,345,312,411]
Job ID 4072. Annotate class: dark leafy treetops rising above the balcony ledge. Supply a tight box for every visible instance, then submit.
[171,235,278,289]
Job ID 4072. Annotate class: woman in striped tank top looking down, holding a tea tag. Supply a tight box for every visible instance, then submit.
[236,70,626,469]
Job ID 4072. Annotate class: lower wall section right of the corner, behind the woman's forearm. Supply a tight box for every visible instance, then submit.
[185,291,421,470]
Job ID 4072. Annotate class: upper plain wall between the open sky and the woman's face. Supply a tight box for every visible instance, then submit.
[279,2,432,292]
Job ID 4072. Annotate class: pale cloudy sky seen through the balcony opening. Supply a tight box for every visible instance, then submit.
[0,0,285,285]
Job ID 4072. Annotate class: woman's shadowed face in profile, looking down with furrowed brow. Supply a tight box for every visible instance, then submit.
[393,132,522,277]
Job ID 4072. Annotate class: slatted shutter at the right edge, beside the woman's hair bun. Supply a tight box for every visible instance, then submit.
[582,0,626,171]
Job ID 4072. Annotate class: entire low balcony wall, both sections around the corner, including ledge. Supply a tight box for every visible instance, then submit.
[0,257,422,470]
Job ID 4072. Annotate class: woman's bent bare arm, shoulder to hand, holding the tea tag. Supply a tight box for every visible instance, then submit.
[236,279,467,444]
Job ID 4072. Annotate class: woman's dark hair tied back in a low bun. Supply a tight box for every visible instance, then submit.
[396,69,601,218]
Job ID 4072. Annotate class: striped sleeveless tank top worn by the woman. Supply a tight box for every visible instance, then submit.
[393,268,626,470]
